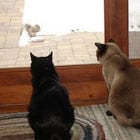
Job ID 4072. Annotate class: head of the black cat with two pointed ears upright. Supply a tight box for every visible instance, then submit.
[30,52,57,80]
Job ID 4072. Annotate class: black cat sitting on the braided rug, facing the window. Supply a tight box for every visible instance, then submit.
[28,52,75,140]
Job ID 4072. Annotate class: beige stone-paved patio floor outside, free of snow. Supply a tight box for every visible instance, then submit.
[0,0,104,68]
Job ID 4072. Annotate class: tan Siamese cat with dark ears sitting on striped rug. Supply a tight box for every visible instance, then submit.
[95,40,140,128]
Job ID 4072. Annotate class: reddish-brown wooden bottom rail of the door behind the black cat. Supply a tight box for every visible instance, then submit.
[0,65,107,113]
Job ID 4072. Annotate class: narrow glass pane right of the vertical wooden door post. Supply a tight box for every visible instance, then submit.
[129,0,140,58]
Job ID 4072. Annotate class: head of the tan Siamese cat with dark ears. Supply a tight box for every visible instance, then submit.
[95,39,122,64]
